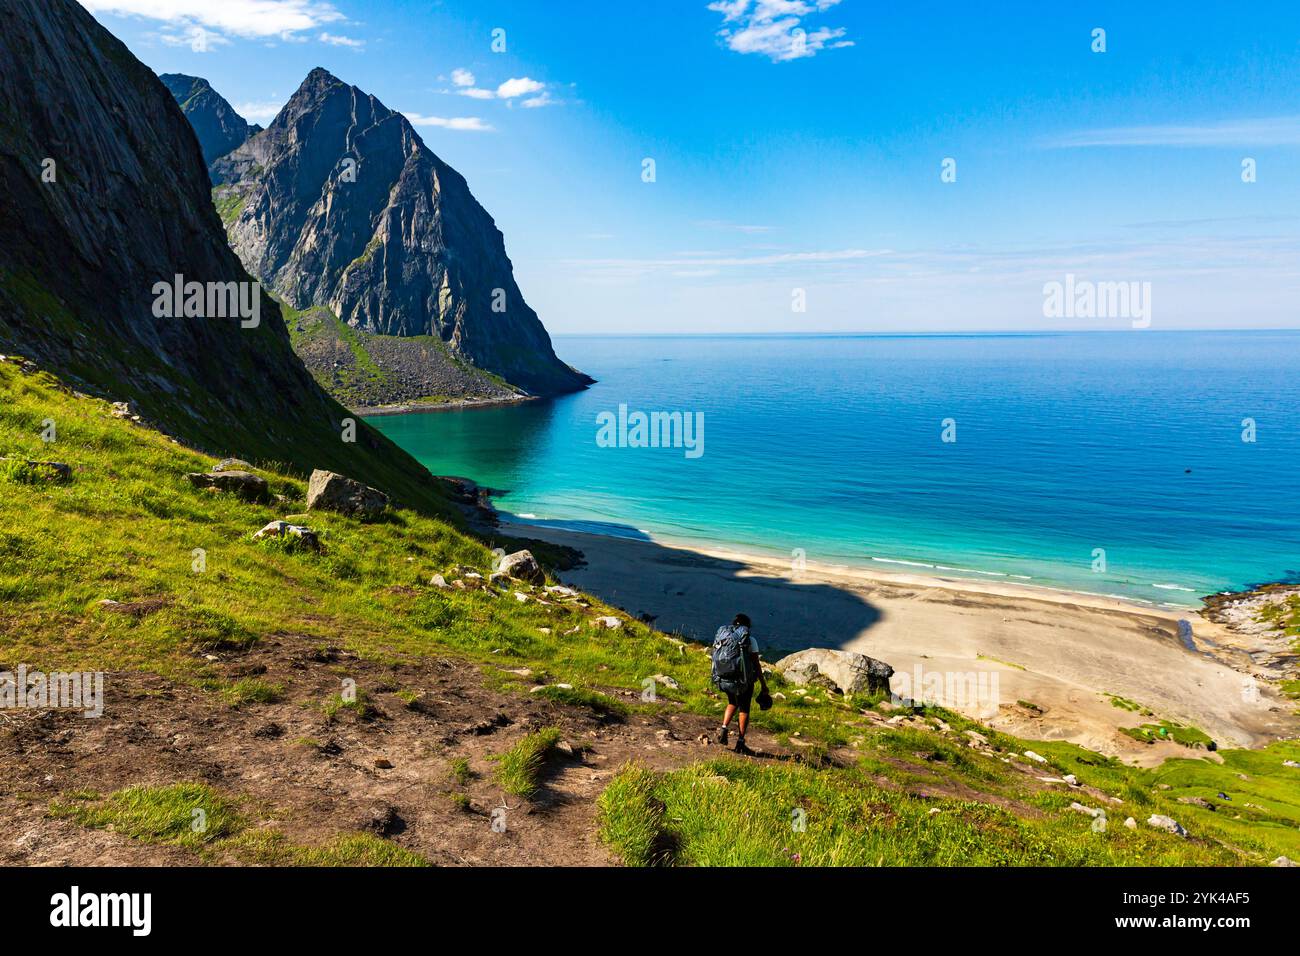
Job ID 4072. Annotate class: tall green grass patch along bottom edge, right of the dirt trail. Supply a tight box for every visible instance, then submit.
[599,760,1232,866]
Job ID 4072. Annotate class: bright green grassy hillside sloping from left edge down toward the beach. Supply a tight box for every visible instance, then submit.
[0,364,1300,865]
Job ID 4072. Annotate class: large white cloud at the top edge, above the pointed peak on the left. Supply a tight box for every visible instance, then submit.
[81,0,347,49]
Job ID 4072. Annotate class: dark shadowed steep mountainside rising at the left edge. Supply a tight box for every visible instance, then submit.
[0,0,437,501]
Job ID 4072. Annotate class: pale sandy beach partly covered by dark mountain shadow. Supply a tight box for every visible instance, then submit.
[507,523,1300,765]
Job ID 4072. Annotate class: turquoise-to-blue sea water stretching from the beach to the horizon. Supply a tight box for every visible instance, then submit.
[371,332,1300,606]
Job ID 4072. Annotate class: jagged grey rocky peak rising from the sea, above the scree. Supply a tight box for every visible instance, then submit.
[212,69,592,394]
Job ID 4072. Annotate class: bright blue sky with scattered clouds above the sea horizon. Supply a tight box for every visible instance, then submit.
[82,0,1300,333]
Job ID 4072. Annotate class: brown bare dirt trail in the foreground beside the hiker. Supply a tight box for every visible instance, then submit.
[0,635,790,866]
